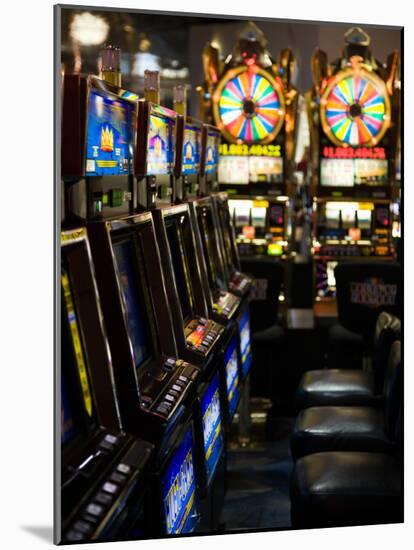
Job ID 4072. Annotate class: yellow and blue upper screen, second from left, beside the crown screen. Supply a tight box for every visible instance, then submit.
[147,114,174,176]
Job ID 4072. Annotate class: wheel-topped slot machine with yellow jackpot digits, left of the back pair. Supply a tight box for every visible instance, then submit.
[199,23,299,256]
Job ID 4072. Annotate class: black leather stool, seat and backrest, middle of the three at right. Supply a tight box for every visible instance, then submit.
[291,341,403,460]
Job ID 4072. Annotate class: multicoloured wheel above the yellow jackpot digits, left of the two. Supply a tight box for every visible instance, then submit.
[213,65,285,144]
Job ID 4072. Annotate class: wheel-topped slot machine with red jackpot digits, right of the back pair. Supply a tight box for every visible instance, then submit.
[307,27,399,299]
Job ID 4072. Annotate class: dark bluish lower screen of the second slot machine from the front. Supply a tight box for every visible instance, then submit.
[113,240,151,368]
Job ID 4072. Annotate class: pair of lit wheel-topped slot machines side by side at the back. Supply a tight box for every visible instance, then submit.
[202,25,401,299]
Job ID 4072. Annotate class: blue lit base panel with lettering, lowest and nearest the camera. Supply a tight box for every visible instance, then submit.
[165,449,194,533]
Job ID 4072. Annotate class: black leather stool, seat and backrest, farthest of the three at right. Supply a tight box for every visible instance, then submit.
[295,311,401,412]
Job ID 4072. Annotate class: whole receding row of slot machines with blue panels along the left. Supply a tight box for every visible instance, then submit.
[57,47,252,543]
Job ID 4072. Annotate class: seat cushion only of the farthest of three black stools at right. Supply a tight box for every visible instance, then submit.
[295,369,377,411]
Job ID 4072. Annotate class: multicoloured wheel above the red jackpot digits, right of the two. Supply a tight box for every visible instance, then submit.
[320,69,391,147]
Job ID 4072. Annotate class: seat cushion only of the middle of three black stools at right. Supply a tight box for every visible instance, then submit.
[291,407,394,460]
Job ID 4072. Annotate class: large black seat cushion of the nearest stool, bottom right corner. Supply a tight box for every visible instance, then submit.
[290,452,403,528]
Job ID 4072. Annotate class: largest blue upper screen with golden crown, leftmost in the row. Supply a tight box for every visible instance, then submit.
[85,90,135,176]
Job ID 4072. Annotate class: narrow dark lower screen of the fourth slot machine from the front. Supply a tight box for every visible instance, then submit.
[197,208,225,290]
